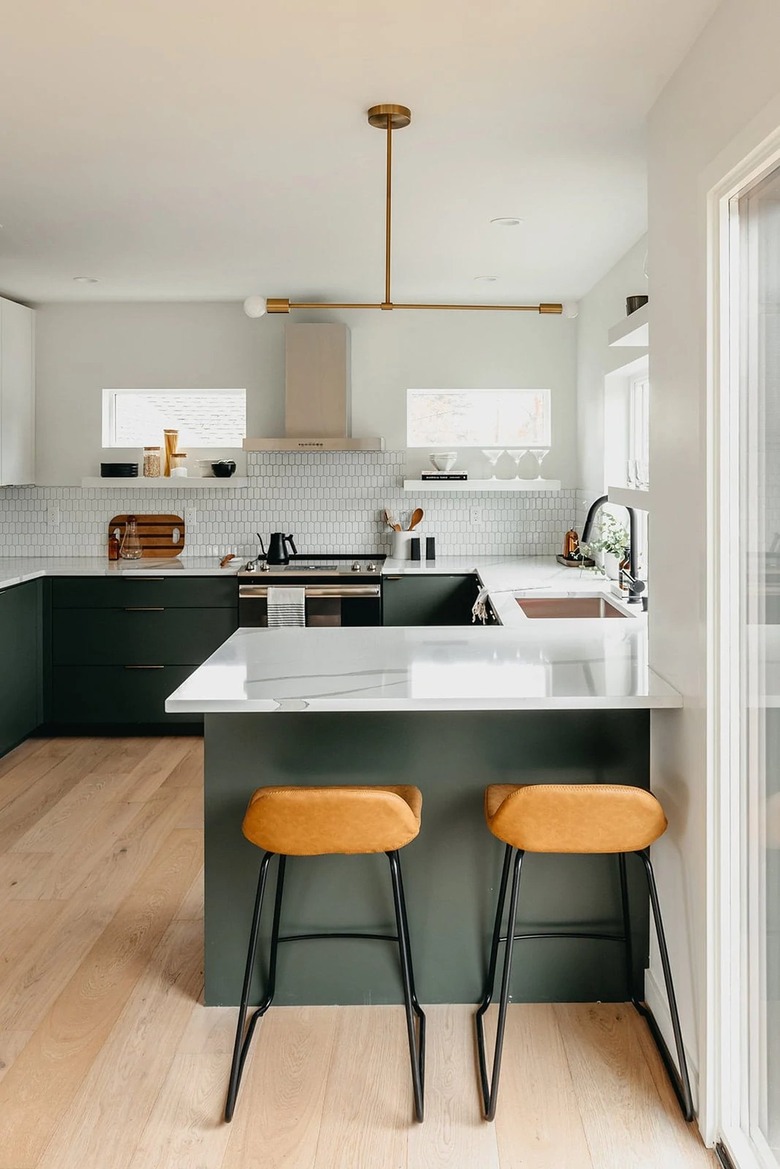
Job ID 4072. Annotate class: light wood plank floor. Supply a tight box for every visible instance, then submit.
[0,738,716,1169]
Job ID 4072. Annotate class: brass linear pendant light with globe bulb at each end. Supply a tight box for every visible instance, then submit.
[243,105,577,317]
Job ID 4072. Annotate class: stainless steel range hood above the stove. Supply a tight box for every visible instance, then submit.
[243,324,385,451]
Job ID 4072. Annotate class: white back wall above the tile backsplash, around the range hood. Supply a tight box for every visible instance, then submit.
[36,304,578,486]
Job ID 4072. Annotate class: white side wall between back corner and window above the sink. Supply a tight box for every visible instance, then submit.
[577,236,649,499]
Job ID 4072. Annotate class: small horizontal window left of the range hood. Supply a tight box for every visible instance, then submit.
[103,389,247,450]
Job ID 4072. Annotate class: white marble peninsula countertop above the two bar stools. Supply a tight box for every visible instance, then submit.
[165,620,682,713]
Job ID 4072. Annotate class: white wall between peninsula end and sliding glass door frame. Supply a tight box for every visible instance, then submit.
[648,0,780,1135]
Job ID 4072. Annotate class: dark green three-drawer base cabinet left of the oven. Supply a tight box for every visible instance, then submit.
[47,569,239,727]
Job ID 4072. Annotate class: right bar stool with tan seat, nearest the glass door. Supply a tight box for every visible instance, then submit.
[476,783,693,1120]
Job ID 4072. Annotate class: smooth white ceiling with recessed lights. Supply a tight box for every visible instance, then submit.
[0,0,718,303]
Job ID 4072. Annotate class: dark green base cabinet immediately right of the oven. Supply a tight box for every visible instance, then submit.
[382,573,478,625]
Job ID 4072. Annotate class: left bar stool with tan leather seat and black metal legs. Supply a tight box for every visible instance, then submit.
[225,786,426,1121]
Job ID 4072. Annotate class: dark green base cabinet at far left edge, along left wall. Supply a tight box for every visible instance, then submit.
[0,580,42,755]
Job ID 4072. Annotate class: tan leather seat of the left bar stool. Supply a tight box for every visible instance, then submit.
[242,784,422,857]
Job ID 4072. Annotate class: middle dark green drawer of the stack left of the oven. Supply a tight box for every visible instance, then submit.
[51,606,239,665]
